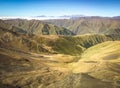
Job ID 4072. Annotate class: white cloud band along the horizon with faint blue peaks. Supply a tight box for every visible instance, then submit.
[0,15,120,20]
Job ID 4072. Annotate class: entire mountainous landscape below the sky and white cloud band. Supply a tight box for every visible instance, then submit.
[0,16,120,88]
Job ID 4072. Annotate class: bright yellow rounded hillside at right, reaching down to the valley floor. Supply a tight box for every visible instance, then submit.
[73,41,120,72]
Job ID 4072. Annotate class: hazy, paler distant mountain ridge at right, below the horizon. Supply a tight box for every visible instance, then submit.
[45,16,120,35]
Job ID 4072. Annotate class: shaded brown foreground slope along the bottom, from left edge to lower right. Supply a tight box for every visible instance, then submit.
[0,50,113,88]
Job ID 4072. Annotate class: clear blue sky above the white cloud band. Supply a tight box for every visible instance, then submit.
[0,0,120,17]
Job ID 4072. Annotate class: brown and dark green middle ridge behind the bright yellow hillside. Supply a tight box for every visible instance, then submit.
[0,28,120,55]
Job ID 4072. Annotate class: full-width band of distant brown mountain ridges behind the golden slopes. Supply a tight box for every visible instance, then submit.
[0,15,120,35]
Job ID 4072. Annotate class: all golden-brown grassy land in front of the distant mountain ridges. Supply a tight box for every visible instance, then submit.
[0,29,120,88]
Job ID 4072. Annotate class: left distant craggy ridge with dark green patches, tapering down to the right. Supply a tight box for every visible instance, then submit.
[0,19,73,35]
